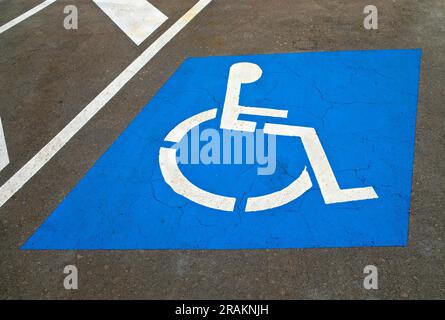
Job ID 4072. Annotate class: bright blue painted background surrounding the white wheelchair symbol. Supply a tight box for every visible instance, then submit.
[22,50,421,249]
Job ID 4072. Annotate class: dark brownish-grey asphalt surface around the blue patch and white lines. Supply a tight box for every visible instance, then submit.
[0,0,445,299]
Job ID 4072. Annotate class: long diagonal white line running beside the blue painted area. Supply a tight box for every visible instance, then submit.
[0,0,212,207]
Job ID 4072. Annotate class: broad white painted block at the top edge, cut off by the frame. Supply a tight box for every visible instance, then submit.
[93,0,168,45]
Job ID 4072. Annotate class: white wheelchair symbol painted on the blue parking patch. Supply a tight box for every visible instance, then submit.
[159,62,378,212]
